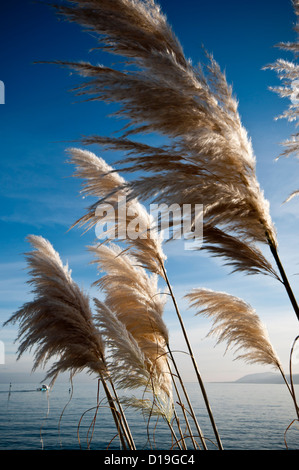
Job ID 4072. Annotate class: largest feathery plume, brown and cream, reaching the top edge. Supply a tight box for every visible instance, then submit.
[52,0,276,250]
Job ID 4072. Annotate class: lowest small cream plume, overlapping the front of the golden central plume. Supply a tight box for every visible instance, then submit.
[94,299,174,422]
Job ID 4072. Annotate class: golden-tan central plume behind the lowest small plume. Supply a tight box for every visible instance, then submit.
[90,244,171,393]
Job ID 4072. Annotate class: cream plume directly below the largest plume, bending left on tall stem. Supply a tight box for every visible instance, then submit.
[68,148,166,277]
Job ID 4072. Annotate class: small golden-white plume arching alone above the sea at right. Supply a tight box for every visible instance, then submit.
[186,289,282,372]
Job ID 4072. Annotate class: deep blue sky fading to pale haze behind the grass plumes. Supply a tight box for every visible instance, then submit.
[0,0,299,380]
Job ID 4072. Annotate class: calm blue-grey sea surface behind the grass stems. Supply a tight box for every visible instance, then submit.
[0,382,299,450]
